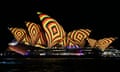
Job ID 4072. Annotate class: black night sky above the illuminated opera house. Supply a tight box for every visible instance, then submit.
[0,0,120,50]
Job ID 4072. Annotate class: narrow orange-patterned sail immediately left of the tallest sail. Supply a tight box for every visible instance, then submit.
[26,22,46,47]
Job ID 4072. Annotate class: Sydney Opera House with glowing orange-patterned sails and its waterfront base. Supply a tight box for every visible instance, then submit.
[0,12,119,57]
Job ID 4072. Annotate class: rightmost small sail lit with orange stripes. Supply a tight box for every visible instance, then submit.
[96,37,116,51]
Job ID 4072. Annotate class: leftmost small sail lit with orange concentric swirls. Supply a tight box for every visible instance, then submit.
[9,28,31,45]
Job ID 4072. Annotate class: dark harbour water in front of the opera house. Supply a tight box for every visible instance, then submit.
[0,57,120,72]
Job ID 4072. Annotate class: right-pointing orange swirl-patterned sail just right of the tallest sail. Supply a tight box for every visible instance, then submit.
[68,29,91,47]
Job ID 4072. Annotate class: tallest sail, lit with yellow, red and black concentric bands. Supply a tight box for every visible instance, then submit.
[38,13,66,48]
